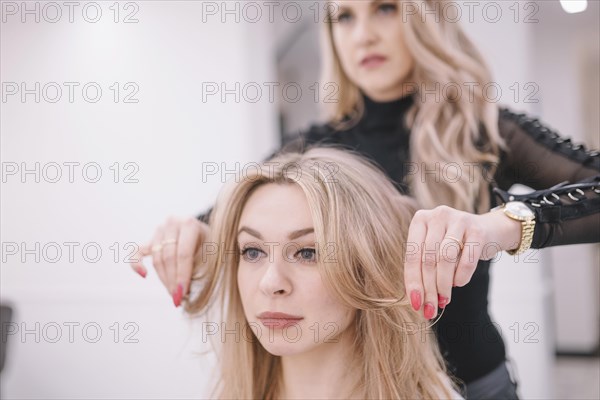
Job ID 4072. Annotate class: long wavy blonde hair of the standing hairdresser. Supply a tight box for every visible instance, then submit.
[321,0,504,212]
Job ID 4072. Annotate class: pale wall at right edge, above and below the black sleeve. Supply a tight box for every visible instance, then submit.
[534,1,600,353]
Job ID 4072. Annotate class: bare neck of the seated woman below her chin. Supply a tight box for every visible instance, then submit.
[280,335,357,399]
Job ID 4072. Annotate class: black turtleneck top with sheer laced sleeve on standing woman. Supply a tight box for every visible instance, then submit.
[284,96,600,383]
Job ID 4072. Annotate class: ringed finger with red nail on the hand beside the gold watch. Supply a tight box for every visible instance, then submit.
[437,230,464,308]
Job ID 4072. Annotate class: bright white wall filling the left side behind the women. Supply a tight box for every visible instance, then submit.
[0,1,278,399]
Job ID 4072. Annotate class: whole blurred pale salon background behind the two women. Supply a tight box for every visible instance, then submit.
[0,0,600,399]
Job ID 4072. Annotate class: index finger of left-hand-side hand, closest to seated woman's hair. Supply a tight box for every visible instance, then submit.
[176,220,205,295]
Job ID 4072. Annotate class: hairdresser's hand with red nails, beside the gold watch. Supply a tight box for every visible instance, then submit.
[404,206,521,319]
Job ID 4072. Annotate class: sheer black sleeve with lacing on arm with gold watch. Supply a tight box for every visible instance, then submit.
[494,109,600,248]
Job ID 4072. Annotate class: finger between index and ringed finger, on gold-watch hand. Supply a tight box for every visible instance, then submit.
[422,222,446,319]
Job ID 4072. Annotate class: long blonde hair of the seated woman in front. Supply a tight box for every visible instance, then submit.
[185,147,458,399]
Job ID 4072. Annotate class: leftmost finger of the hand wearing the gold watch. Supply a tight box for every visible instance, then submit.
[404,211,427,311]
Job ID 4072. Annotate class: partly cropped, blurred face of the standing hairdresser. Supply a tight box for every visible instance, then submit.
[331,0,413,101]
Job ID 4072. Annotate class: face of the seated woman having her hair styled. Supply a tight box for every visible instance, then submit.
[238,184,354,356]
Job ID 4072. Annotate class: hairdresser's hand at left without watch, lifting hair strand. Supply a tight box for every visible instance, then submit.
[131,217,210,307]
